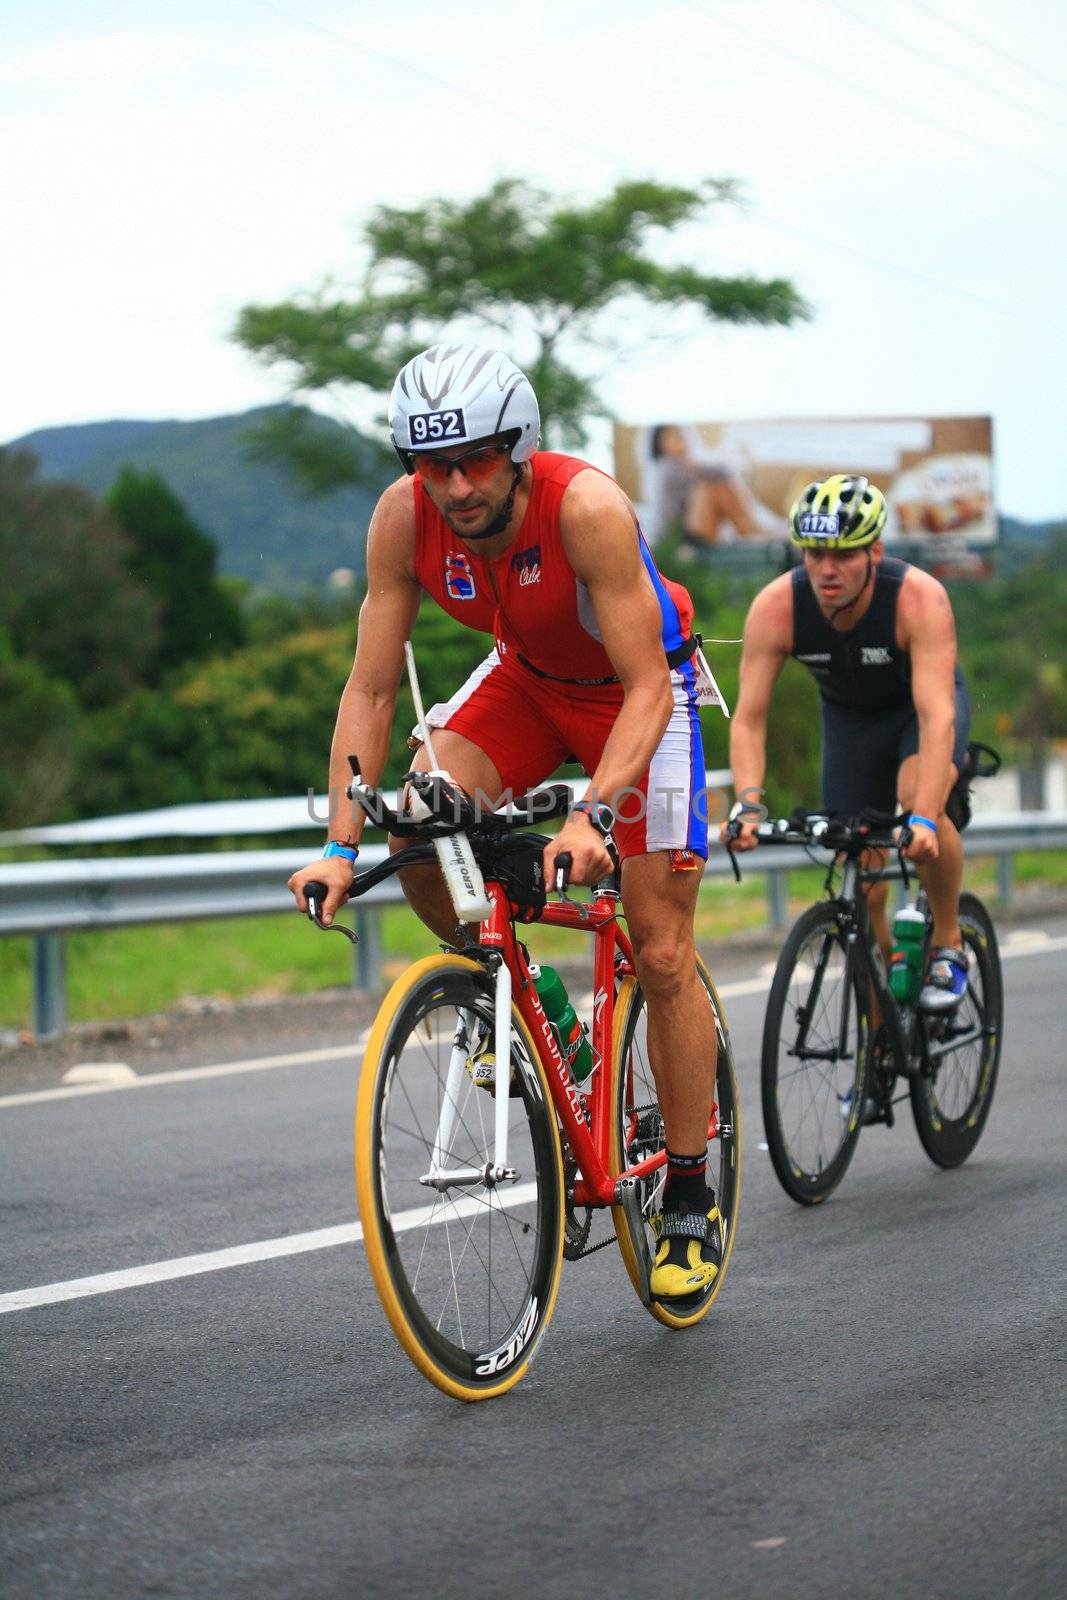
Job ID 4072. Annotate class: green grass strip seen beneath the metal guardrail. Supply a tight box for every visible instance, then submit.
[0,851,1067,1029]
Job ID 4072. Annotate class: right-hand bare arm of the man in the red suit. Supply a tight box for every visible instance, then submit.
[545,472,673,882]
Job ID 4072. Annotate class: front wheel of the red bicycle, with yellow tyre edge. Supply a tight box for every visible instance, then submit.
[355,955,563,1400]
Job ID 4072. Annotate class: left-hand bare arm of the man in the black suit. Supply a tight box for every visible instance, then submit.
[729,573,793,850]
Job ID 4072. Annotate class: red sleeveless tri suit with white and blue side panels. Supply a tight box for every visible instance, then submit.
[414,450,707,867]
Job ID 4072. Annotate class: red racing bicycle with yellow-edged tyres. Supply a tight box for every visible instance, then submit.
[306,774,741,1400]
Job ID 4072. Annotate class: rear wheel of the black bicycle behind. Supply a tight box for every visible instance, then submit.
[909,894,1005,1166]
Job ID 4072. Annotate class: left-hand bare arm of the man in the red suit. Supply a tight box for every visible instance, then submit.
[290,478,419,922]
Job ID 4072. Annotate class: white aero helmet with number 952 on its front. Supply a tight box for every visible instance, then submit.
[389,344,541,472]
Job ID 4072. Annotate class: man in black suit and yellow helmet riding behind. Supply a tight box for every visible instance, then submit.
[729,474,971,1011]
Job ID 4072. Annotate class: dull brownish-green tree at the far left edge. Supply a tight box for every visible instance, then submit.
[0,450,158,707]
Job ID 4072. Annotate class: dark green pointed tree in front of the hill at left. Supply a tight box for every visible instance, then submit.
[106,467,243,680]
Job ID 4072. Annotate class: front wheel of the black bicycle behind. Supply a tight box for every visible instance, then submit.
[760,904,870,1205]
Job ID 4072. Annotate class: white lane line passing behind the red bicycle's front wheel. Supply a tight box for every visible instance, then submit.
[0,1182,537,1315]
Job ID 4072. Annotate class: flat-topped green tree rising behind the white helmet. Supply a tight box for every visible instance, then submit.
[235,178,808,491]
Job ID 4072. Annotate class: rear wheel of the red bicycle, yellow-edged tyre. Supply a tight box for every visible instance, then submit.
[611,957,741,1328]
